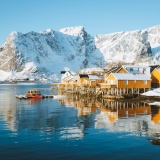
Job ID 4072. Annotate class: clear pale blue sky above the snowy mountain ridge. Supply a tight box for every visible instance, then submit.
[0,0,160,45]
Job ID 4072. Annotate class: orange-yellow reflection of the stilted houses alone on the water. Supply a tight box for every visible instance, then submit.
[60,96,160,124]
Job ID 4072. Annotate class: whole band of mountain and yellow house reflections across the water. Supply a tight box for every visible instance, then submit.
[0,85,160,139]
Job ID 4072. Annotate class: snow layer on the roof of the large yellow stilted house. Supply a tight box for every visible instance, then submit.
[112,73,151,80]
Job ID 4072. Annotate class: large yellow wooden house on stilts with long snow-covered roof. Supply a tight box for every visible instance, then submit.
[100,73,151,95]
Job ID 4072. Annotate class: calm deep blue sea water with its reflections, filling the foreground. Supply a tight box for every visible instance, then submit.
[0,83,160,160]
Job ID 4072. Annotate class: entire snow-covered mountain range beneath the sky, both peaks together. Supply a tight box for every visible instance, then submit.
[0,26,160,81]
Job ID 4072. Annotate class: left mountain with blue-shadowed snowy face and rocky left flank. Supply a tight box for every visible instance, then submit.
[0,27,103,80]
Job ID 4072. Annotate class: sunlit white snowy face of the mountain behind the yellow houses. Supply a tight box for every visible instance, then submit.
[95,31,150,63]
